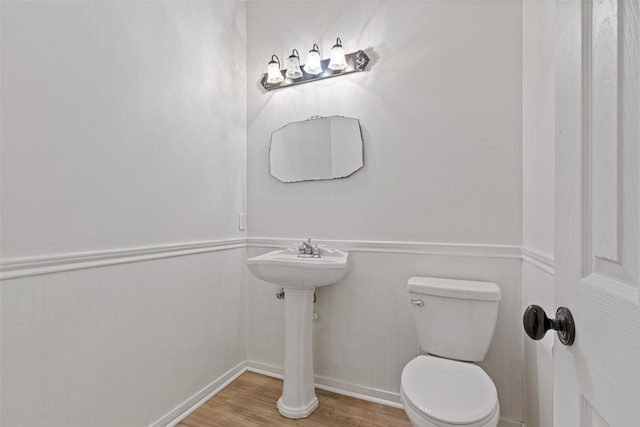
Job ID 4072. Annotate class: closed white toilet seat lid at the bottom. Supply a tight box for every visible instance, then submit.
[400,356,499,427]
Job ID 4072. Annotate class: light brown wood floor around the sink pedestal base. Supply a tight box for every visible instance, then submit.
[178,372,411,427]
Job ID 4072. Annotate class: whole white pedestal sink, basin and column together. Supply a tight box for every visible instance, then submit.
[247,248,349,419]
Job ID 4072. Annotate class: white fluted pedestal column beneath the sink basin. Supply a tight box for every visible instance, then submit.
[278,288,318,419]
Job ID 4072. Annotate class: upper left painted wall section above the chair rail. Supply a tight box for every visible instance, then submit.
[0,1,246,259]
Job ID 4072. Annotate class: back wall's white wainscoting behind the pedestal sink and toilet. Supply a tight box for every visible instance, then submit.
[247,238,523,425]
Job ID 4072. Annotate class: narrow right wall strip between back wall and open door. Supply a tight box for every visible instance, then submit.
[522,1,556,427]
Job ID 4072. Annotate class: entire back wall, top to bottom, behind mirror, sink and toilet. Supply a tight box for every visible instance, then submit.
[247,1,523,422]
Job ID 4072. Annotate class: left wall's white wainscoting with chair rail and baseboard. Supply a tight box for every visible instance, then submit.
[0,240,246,427]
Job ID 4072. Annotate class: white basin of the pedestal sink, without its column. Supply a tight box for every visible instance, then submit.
[247,248,349,289]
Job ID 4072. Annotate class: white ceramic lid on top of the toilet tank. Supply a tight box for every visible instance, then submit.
[407,276,500,301]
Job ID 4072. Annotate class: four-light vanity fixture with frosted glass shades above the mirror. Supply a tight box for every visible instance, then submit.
[260,37,369,90]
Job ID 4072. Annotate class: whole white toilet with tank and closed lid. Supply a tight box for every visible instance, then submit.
[400,276,500,427]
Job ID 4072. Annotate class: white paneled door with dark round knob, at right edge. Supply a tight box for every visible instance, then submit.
[550,0,640,427]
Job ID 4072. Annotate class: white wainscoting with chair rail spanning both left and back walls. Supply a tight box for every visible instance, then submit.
[1,238,524,427]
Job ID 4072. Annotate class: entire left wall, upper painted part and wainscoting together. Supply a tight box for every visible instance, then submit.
[0,1,246,427]
